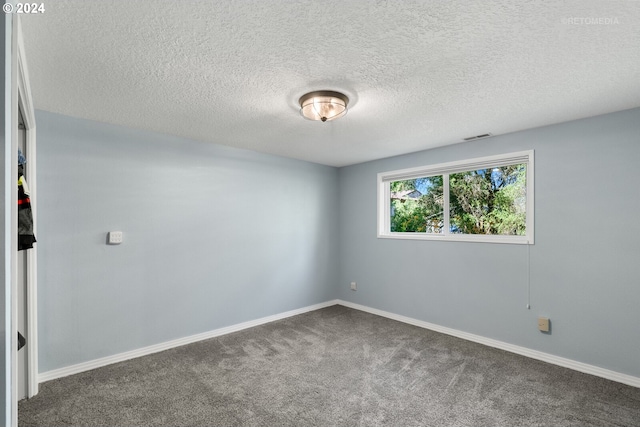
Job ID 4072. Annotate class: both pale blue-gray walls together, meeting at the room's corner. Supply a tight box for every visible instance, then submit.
[36,109,640,382]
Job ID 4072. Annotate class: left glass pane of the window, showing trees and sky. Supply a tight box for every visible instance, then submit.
[390,175,444,233]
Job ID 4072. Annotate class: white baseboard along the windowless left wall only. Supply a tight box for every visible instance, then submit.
[38,300,338,383]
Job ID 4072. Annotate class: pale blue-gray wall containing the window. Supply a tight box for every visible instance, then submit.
[337,109,640,377]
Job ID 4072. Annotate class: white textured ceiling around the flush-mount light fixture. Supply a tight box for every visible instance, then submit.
[22,0,640,166]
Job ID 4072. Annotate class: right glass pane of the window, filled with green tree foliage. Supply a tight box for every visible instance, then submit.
[449,164,527,236]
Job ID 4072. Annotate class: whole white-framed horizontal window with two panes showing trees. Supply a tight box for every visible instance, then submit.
[378,151,534,244]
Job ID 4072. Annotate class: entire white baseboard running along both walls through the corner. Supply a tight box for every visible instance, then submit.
[38,300,640,388]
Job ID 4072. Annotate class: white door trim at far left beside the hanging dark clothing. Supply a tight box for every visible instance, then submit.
[15,15,38,398]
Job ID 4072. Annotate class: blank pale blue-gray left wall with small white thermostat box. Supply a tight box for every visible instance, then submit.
[36,111,338,372]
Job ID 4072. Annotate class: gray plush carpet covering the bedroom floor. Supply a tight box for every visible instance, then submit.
[18,306,640,426]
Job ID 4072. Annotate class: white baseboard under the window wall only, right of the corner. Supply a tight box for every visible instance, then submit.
[336,300,640,388]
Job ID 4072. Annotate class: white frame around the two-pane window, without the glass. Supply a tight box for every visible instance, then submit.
[378,150,535,245]
